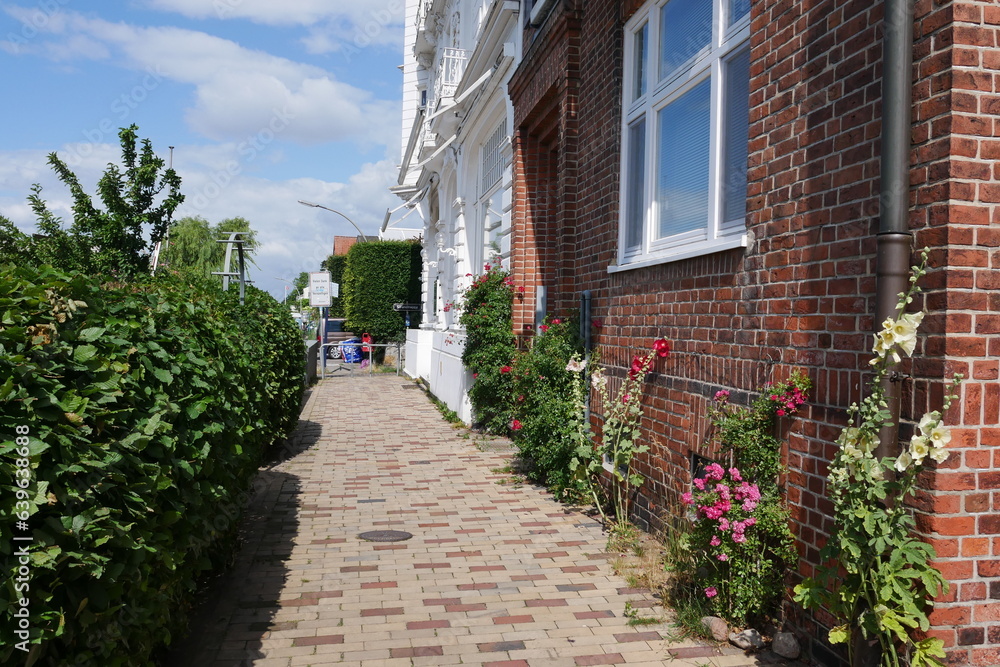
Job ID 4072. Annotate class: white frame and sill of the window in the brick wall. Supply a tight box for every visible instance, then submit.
[608,0,750,272]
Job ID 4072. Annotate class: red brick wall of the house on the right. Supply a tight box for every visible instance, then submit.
[511,0,1000,665]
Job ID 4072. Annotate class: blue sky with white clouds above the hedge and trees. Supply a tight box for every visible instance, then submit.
[0,0,404,299]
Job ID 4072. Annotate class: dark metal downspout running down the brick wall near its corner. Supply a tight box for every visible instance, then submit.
[875,0,913,456]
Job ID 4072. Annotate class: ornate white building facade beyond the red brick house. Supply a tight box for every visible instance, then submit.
[386,0,522,423]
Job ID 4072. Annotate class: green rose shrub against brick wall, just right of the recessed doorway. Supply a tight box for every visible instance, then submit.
[513,319,580,497]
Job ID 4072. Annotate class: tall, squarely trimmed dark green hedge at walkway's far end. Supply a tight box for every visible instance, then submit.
[343,241,423,342]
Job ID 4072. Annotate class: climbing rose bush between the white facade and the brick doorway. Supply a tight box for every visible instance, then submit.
[458,264,517,435]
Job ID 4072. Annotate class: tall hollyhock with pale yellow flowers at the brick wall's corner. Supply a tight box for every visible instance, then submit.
[794,248,962,667]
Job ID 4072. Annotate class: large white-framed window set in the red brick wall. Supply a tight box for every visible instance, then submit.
[618,0,750,268]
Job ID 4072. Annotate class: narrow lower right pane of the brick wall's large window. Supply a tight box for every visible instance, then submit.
[722,49,750,222]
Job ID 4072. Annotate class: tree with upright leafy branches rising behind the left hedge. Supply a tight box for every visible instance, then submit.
[0,125,184,277]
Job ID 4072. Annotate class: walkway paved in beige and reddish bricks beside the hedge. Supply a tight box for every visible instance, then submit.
[167,375,788,667]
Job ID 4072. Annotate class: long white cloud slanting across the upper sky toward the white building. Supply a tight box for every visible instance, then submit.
[8,10,399,146]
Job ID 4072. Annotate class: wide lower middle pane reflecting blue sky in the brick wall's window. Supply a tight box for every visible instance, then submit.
[656,79,712,238]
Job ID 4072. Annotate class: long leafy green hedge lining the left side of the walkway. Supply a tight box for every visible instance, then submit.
[0,266,303,667]
